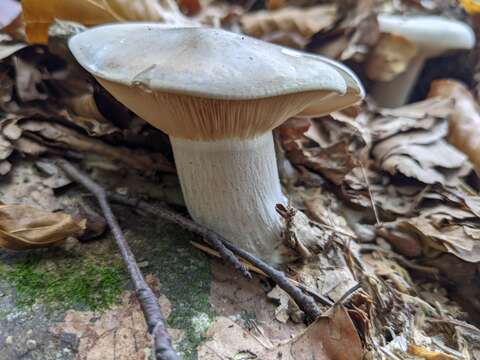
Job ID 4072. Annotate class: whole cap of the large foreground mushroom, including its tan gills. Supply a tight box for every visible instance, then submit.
[69,23,362,140]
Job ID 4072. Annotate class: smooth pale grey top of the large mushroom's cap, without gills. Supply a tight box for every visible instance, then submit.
[69,23,364,100]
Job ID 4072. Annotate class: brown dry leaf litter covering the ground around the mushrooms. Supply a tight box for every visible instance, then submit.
[0,0,480,360]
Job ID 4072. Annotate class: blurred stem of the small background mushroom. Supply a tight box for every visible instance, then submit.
[372,54,425,108]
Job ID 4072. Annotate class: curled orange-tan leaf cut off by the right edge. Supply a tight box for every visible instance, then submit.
[429,80,480,179]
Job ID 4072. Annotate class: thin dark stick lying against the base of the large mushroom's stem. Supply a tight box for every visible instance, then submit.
[109,194,321,320]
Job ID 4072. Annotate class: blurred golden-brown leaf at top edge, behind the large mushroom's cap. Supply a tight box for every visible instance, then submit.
[22,0,195,44]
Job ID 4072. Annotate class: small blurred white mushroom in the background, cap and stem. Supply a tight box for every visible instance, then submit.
[372,15,475,107]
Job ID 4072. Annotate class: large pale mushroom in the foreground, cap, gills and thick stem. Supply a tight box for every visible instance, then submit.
[69,23,363,264]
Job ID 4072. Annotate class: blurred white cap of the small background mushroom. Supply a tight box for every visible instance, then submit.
[378,15,475,52]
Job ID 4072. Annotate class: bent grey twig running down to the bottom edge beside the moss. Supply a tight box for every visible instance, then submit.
[56,159,180,360]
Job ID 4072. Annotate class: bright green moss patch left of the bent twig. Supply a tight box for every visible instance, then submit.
[5,256,124,310]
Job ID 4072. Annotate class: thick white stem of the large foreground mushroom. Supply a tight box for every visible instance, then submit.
[170,132,286,264]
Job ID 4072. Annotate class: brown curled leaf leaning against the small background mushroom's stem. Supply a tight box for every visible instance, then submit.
[366,33,417,81]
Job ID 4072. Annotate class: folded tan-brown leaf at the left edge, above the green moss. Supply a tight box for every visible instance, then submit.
[0,204,85,250]
